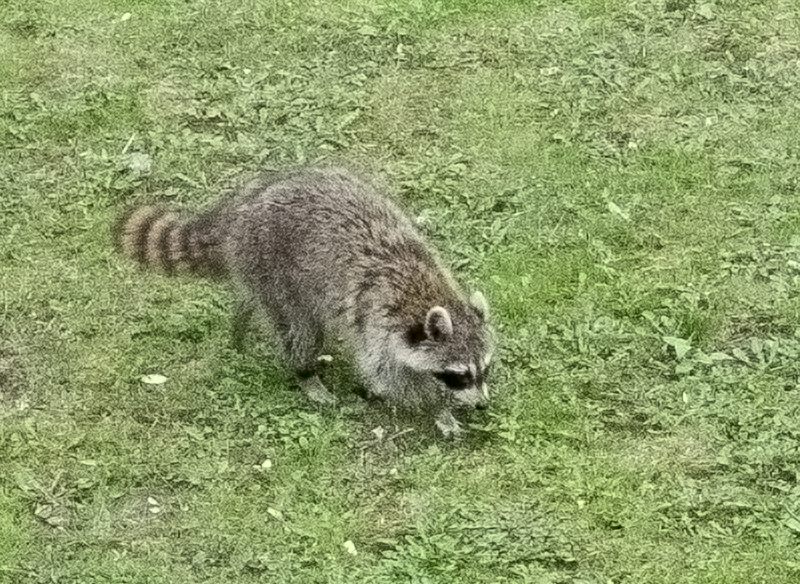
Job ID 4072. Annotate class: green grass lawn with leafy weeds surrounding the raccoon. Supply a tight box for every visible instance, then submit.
[0,0,800,584]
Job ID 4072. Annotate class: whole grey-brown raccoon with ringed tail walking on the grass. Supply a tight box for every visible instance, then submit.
[117,168,493,436]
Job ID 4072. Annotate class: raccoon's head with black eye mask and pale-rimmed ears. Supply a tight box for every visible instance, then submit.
[400,292,493,409]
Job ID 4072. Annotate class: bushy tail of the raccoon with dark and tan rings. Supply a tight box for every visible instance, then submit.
[115,205,225,276]
